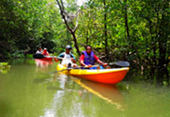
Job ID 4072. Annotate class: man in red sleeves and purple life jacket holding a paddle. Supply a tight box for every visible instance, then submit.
[79,45,108,69]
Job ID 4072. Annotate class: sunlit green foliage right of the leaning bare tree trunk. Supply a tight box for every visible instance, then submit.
[77,0,170,68]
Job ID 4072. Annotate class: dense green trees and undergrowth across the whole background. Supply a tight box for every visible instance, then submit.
[0,0,170,69]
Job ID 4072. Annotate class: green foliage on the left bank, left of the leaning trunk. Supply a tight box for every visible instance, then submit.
[0,0,70,58]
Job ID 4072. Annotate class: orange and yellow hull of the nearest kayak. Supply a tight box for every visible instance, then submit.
[57,65,129,84]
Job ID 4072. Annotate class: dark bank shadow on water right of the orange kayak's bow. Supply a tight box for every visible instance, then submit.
[124,67,170,86]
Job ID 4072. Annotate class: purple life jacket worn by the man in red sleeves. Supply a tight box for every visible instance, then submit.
[83,51,95,65]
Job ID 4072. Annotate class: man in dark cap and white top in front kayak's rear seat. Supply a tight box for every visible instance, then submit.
[54,45,77,67]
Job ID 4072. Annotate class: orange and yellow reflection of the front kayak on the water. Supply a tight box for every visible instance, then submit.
[72,78,125,110]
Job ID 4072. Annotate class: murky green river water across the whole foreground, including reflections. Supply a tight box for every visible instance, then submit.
[0,59,170,117]
